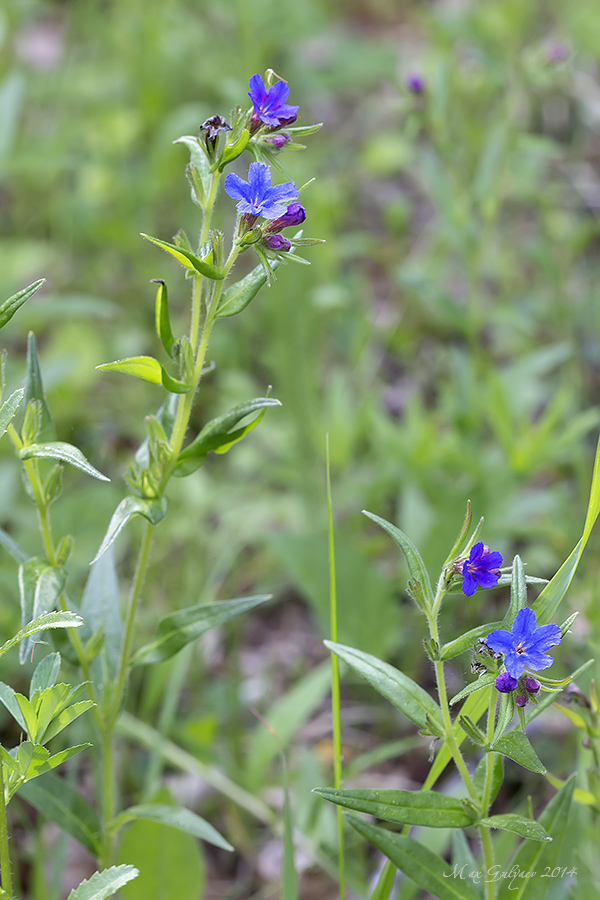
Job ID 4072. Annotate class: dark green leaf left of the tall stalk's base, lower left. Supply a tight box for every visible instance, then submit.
[19,774,101,856]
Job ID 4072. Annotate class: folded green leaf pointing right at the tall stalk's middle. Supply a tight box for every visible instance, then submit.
[175,397,281,477]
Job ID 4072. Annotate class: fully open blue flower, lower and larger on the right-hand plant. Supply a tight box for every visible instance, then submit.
[485,607,562,690]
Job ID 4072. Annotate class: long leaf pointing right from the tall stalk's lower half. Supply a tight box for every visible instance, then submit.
[133,594,271,665]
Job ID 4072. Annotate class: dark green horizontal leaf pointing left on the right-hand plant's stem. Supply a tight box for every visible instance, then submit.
[314,788,474,828]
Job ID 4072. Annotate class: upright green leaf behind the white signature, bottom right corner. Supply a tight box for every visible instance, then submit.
[499,774,577,900]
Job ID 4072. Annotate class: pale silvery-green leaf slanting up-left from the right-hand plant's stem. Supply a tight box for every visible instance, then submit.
[324,641,444,728]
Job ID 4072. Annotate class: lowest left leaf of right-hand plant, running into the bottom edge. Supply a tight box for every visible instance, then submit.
[348,816,479,900]
